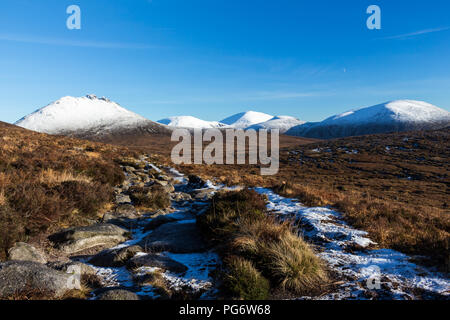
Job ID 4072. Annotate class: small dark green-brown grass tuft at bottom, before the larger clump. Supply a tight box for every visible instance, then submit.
[224,256,270,300]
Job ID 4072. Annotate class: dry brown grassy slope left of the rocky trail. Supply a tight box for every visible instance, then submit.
[0,122,136,260]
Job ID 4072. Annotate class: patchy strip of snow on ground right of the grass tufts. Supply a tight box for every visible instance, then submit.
[255,188,450,299]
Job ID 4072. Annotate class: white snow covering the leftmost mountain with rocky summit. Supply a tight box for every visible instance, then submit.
[15,95,159,134]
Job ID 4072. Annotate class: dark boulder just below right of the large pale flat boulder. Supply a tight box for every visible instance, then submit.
[89,245,144,267]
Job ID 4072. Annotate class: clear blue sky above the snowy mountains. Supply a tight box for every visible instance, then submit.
[0,0,450,123]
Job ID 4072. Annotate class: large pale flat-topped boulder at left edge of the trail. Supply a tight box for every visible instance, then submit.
[49,223,129,254]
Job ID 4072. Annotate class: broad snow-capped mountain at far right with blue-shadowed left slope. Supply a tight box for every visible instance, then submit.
[286,100,450,139]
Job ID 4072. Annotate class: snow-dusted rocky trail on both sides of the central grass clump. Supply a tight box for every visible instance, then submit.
[0,156,450,300]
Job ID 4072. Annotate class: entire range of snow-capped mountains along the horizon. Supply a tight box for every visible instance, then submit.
[15,95,450,140]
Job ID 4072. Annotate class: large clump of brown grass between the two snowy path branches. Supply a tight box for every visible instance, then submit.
[197,189,328,299]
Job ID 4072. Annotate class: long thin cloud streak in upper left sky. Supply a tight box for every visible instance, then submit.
[0,34,162,49]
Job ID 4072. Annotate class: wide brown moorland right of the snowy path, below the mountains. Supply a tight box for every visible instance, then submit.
[177,129,450,271]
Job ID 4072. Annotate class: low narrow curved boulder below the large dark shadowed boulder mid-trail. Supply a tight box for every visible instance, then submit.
[127,253,188,273]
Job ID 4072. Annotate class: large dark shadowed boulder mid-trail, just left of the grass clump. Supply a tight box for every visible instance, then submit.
[140,222,207,253]
